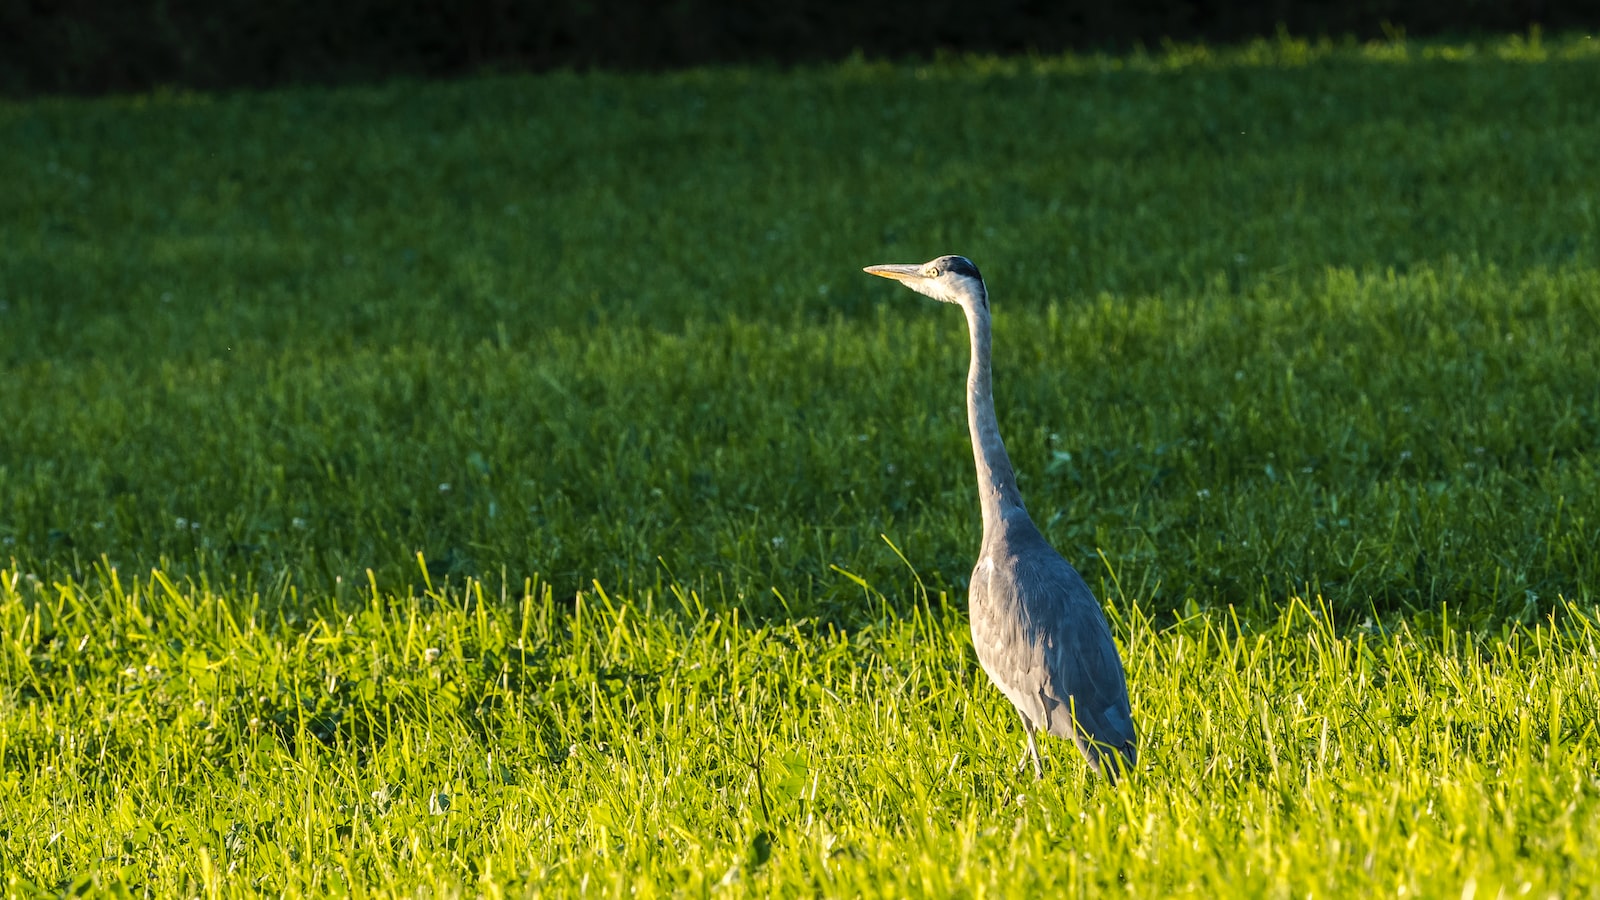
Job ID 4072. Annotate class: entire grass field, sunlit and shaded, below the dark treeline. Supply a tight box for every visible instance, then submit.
[0,34,1600,898]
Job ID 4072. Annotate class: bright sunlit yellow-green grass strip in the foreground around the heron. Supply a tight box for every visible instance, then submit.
[9,572,1600,897]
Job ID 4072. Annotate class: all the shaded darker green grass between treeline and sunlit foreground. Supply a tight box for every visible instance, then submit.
[0,38,1600,621]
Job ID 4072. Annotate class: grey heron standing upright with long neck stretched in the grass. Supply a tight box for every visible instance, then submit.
[866,256,1138,780]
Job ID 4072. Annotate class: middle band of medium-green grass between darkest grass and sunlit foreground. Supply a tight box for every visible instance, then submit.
[0,264,1600,625]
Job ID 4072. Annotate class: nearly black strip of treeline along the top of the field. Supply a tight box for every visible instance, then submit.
[0,0,1600,96]
